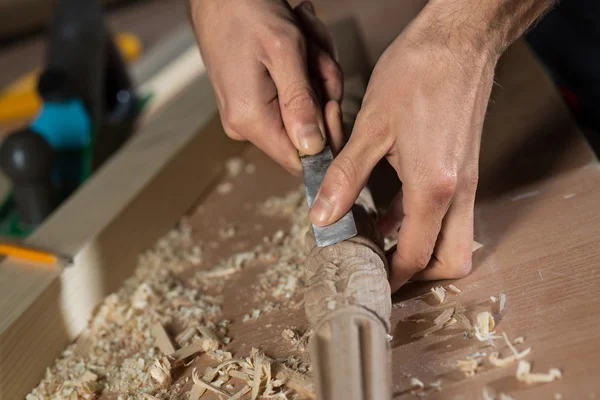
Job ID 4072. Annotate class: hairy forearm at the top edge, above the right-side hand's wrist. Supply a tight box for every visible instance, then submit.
[422,0,557,57]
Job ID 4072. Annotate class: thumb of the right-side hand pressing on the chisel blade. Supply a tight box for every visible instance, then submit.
[309,111,392,226]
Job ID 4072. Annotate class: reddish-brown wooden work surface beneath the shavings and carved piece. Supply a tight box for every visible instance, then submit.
[165,39,600,399]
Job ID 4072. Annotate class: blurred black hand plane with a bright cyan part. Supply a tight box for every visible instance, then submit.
[0,0,143,236]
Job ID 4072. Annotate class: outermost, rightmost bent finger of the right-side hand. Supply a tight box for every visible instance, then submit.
[412,181,475,280]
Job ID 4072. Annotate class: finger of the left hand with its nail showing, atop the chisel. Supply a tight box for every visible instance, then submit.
[267,35,325,154]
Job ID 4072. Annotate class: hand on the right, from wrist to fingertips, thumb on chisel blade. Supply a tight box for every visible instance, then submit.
[309,4,497,292]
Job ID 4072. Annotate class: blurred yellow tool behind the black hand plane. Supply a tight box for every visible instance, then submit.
[0,33,142,123]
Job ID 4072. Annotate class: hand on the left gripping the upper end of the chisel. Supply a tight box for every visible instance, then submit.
[190,0,343,175]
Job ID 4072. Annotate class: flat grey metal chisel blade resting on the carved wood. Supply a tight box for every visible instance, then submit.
[300,146,356,247]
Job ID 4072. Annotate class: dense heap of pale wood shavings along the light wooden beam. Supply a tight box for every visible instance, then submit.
[27,220,227,400]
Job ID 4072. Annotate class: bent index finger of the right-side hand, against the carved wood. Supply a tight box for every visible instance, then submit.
[390,178,455,292]
